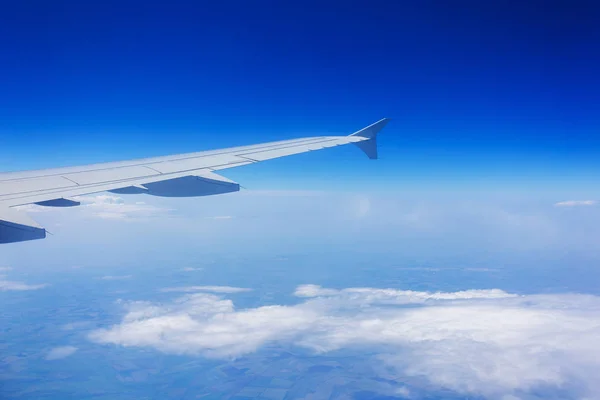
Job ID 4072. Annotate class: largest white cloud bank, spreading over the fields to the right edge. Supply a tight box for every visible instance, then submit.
[90,285,600,399]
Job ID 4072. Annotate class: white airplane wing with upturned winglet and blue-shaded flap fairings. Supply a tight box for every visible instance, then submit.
[0,118,389,243]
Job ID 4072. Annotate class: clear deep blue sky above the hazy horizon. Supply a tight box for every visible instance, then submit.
[0,0,600,189]
